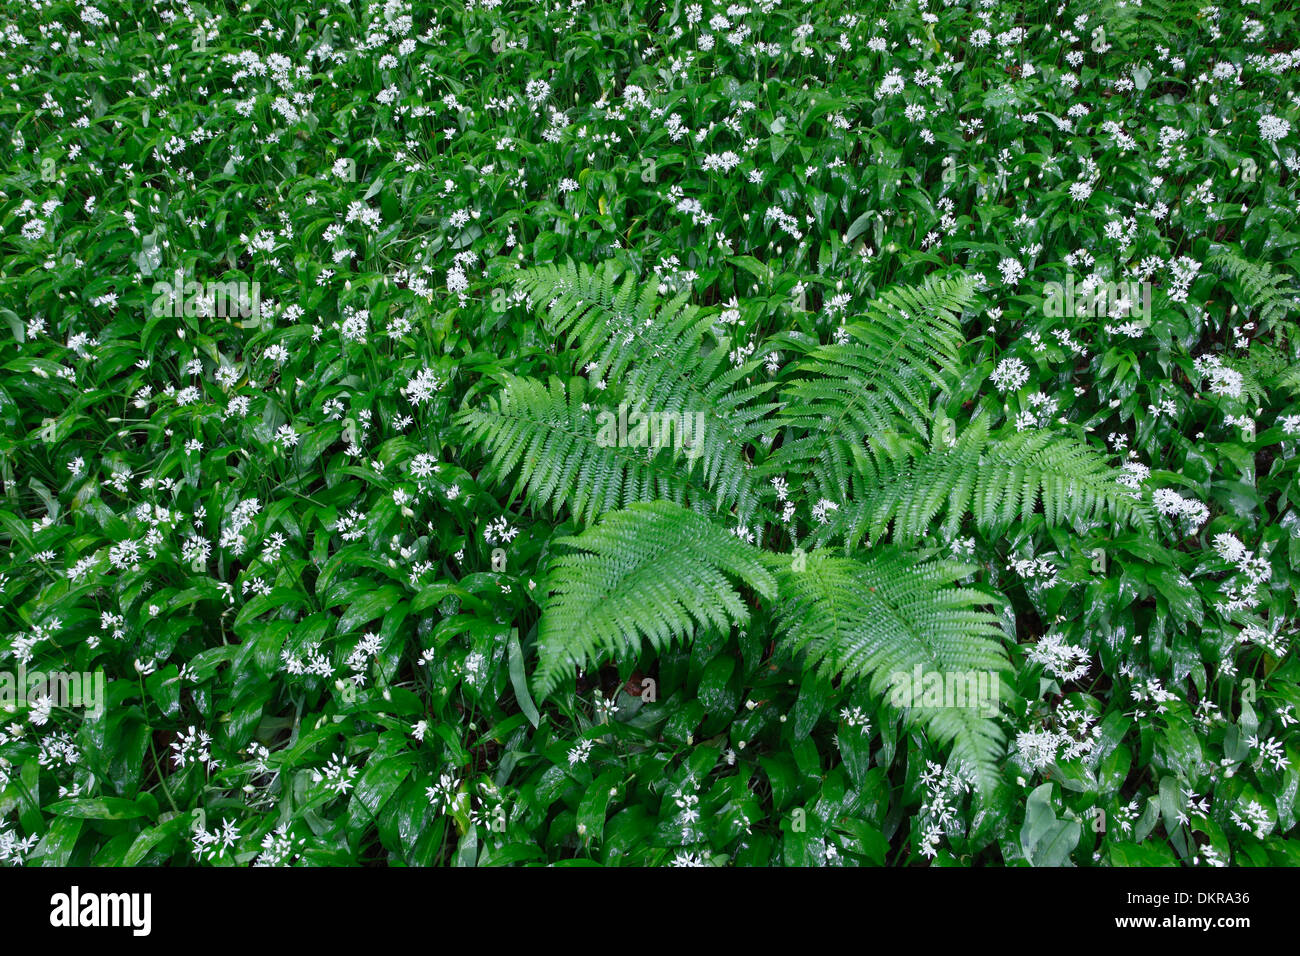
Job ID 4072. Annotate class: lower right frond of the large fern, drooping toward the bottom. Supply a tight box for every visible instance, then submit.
[770,548,1009,782]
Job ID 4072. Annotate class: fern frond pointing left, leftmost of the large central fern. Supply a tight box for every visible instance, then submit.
[456,375,714,524]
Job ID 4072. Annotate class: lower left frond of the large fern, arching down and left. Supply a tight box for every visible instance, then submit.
[537,502,776,695]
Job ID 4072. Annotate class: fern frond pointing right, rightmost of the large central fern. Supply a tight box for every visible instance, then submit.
[822,419,1151,546]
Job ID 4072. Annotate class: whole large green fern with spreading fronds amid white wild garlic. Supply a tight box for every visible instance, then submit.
[459,257,1149,784]
